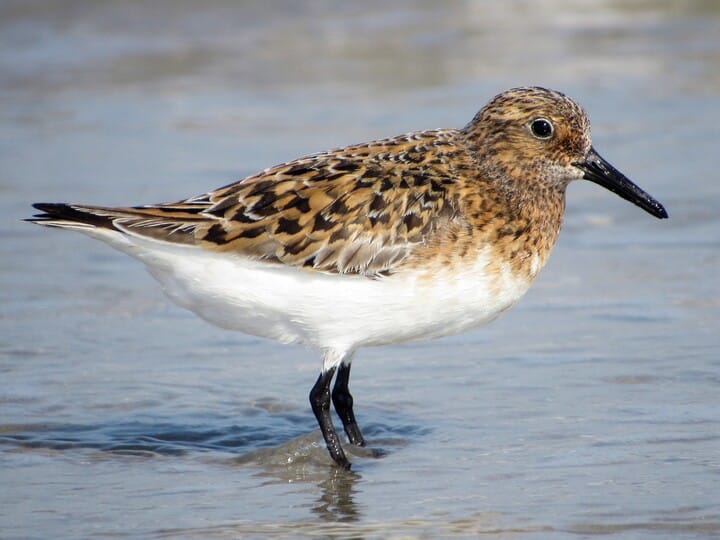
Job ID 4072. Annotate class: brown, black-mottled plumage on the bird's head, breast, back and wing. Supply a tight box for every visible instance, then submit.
[40,91,589,276]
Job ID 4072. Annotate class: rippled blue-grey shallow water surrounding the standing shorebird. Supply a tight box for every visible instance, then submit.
[0,0,720,539]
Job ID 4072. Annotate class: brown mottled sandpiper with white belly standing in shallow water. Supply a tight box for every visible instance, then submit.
[27,86,668,469]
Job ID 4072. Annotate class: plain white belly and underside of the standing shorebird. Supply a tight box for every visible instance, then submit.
[83,228,531,352]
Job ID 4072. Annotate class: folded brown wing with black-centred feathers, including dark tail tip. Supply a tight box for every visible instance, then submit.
[34,130,470,276]
